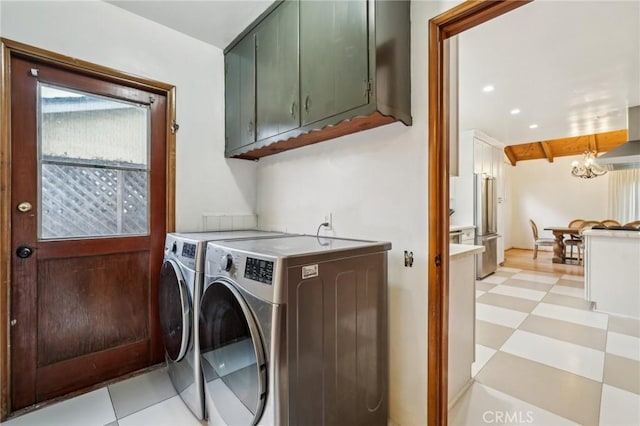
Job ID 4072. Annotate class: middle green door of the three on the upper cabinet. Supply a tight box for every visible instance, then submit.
[256,1,300,140]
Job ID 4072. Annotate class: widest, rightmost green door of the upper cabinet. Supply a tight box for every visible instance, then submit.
[300,0,369,125]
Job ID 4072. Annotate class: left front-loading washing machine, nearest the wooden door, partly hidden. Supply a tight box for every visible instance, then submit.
[158,230,285,419]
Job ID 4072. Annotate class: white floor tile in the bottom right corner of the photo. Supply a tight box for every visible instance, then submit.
[600,385,640,426]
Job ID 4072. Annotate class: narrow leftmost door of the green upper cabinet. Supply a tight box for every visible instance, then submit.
[225,35,256,152]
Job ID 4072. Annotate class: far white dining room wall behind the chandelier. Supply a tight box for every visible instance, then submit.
[505,155,609,248]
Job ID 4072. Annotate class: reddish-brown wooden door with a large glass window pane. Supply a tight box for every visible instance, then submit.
[10,57,167,411]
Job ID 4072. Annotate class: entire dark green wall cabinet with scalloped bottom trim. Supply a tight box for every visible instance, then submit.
[224,0,411,159]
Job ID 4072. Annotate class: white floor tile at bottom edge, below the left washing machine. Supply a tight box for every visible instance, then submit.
[118,396,201,426]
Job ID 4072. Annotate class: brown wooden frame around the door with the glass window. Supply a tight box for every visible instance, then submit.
[0,38,176,420]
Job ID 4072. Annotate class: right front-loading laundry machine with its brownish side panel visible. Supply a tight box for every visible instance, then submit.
[199,236,391,426]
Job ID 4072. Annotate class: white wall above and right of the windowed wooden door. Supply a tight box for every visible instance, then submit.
[0,0,256,231]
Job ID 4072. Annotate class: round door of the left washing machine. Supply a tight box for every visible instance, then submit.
[158,260,191,362]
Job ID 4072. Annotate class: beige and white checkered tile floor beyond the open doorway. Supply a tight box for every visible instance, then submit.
[449,268,640,426]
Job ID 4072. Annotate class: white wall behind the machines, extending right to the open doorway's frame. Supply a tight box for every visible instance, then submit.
[258,1,456,426]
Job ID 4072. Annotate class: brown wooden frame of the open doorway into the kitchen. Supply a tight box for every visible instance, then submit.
[427,0,533,426]
